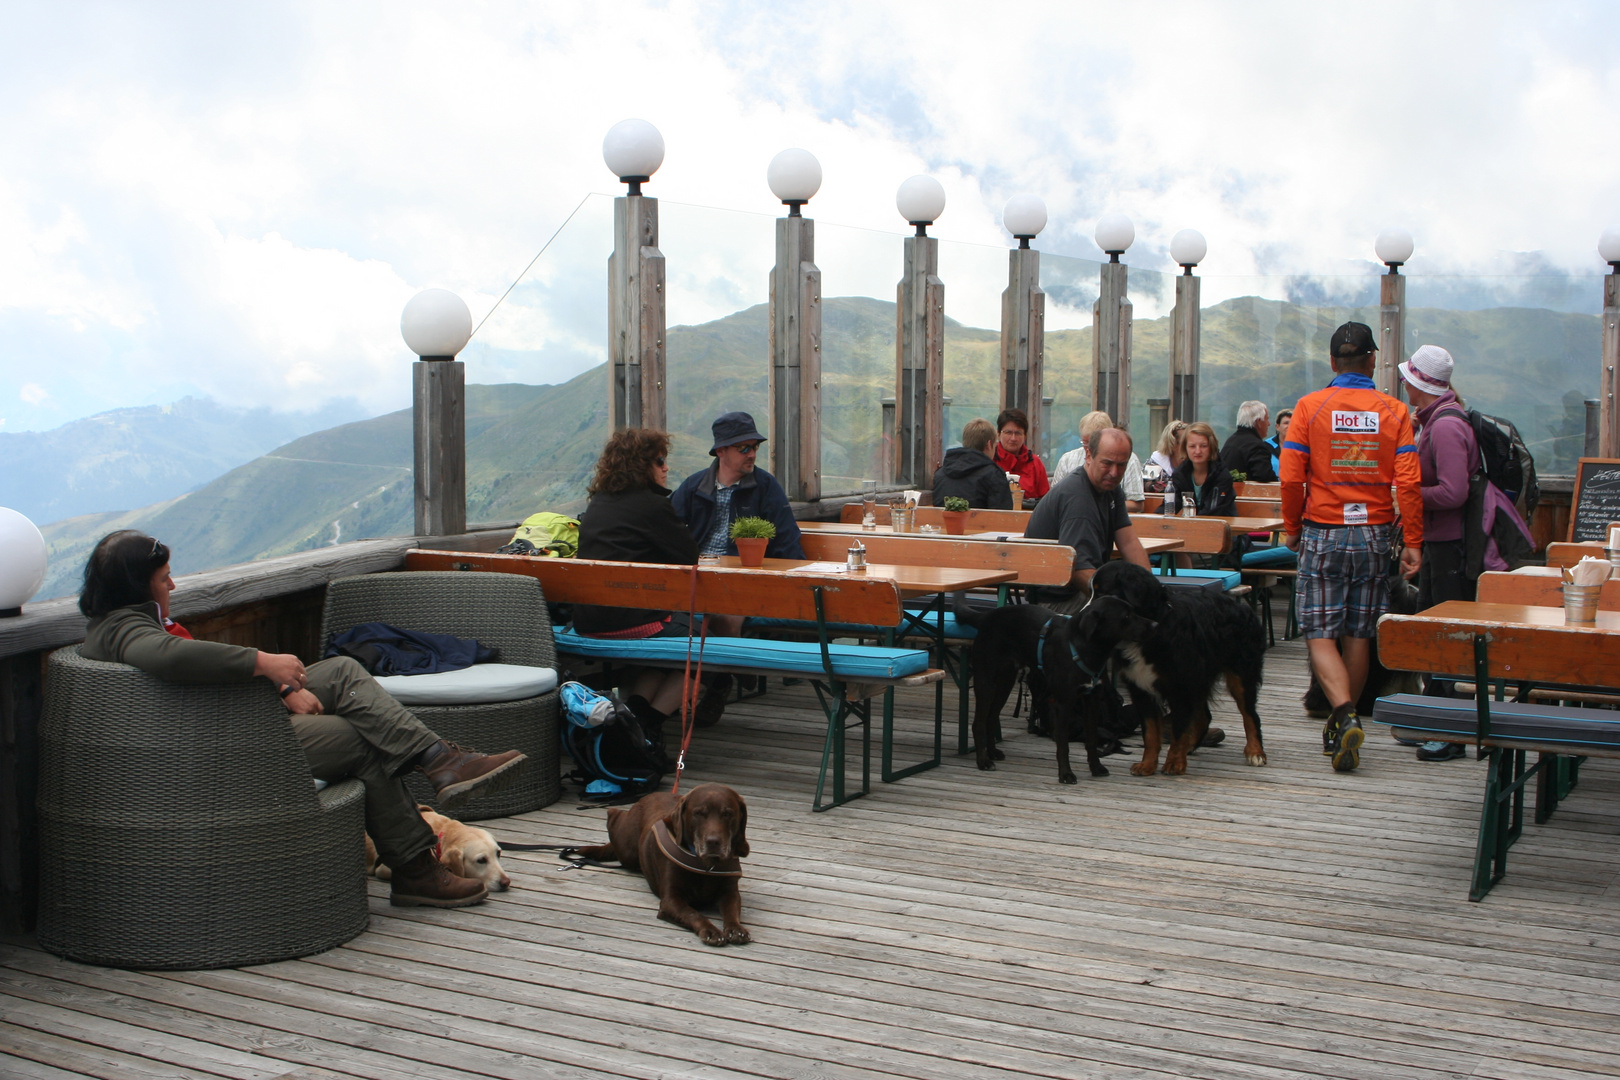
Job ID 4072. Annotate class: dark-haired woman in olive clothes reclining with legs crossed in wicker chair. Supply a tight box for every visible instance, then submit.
[79,529,527,907]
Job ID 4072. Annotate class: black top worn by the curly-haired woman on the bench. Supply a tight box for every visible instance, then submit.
[573,486,698,633]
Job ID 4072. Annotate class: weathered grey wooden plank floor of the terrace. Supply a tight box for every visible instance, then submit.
[0,643,1620,1080]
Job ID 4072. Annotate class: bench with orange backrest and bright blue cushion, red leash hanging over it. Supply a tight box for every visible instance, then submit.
[405,549,944,811]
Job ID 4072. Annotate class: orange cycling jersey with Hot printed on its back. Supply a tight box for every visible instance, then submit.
[1281,372,1422,547]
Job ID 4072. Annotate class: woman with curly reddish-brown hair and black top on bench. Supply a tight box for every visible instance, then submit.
[573,427,698,733]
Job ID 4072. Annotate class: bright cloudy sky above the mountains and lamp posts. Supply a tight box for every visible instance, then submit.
[0,0,1620,431]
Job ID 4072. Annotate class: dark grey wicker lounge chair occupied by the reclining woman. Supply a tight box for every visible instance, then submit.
[39,646,369,968]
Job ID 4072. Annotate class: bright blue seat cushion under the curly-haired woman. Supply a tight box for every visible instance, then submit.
[556,627,928,680]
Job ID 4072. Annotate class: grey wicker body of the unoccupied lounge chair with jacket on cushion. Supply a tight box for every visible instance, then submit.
[321,572,562,821]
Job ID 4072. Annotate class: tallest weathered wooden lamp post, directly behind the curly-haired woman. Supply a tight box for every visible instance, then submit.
[608,194,667,431]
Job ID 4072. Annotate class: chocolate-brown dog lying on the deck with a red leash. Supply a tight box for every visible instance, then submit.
[575,784,752,946]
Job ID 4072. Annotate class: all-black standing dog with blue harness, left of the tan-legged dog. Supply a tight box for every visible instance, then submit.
[956,586,1153,784]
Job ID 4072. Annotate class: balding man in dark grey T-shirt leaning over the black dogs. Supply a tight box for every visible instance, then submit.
[1024,427,1147,614]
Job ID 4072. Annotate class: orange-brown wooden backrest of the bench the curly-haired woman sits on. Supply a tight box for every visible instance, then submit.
[405,549,901,627]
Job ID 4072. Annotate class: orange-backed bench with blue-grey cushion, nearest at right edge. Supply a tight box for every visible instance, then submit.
[1372,615,1620,900]
